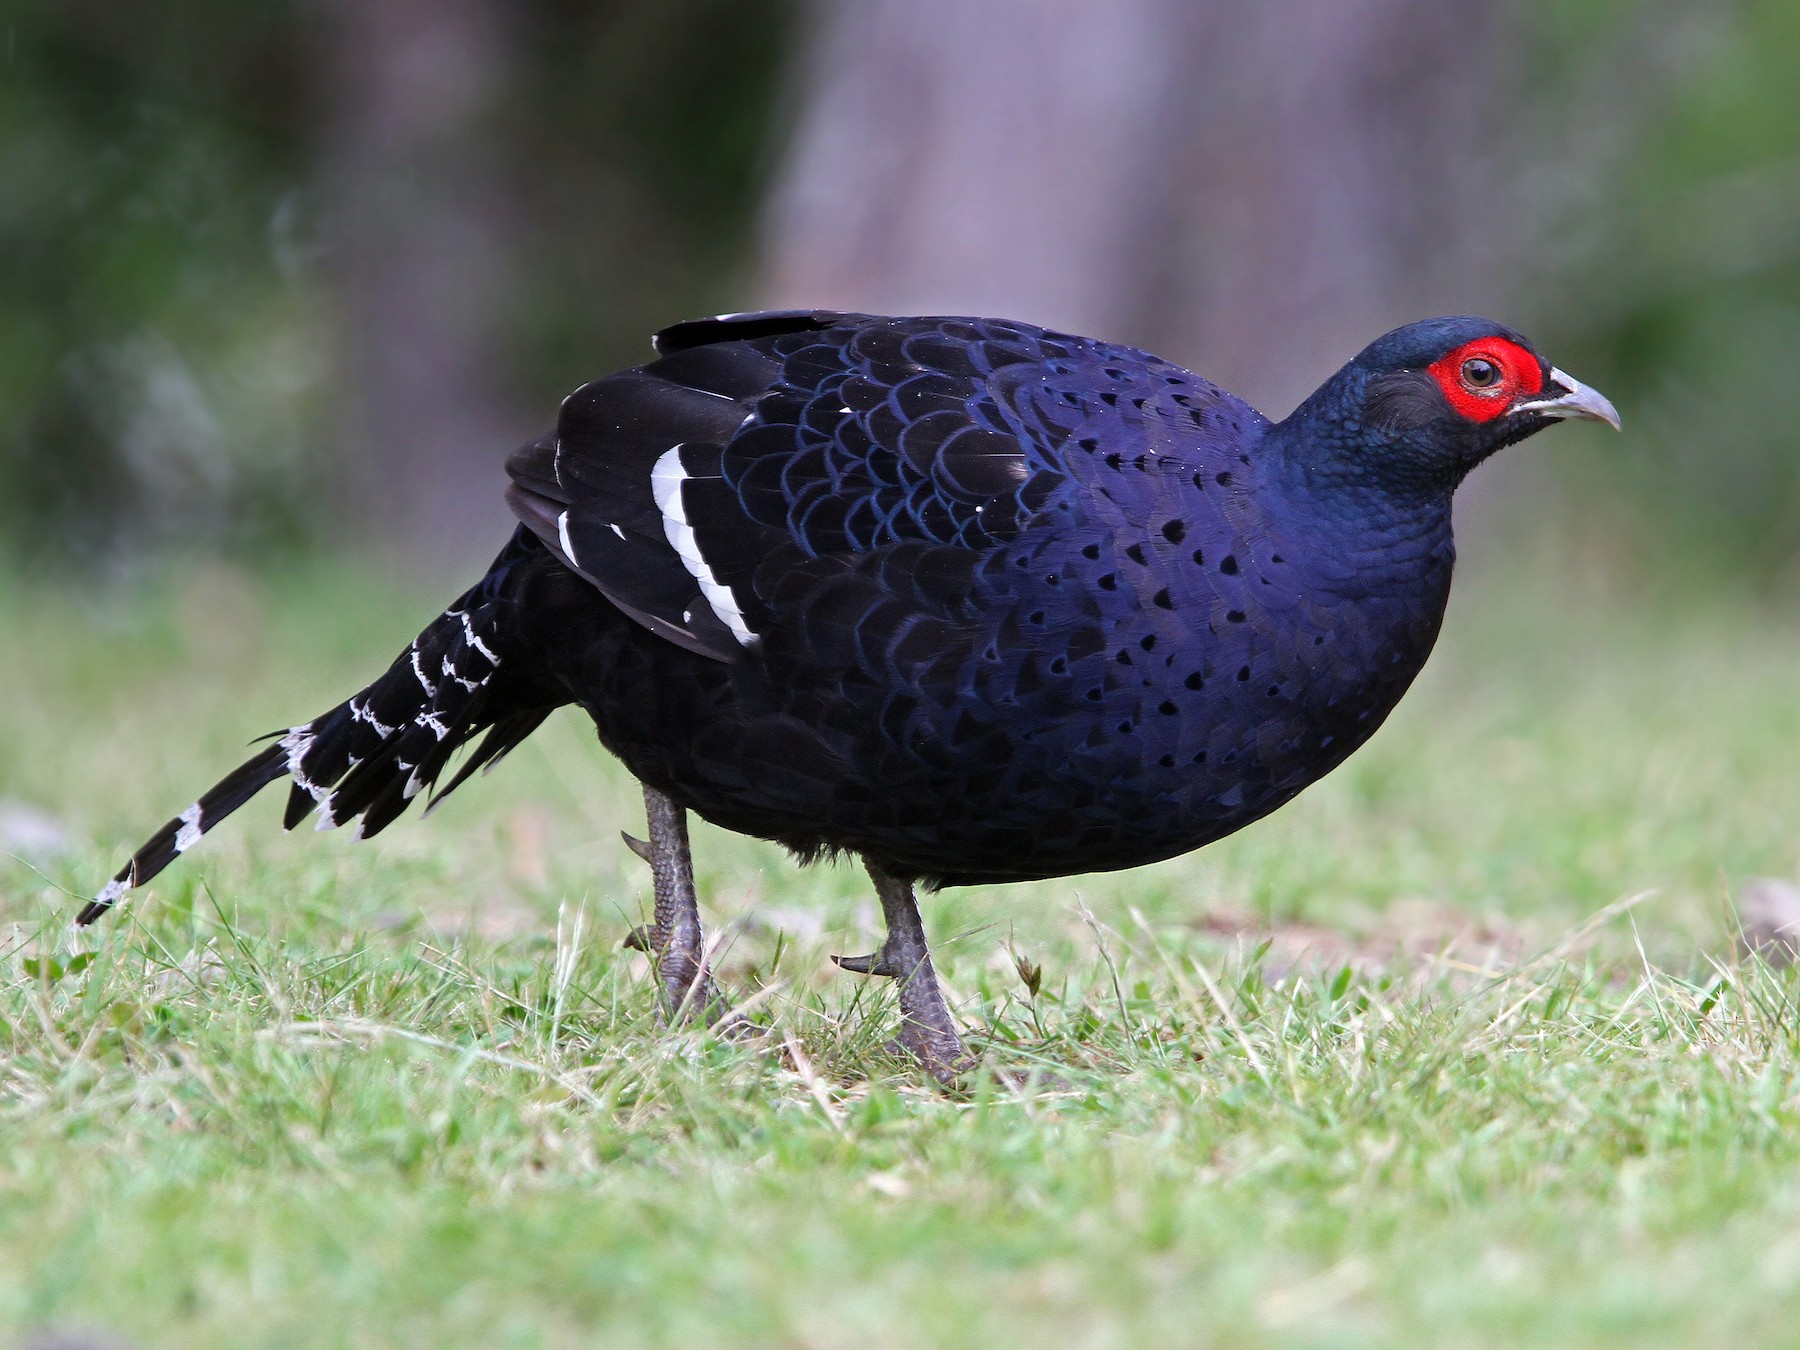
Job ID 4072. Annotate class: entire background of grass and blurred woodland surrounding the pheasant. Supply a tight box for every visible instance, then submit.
[17,0,1800,1350]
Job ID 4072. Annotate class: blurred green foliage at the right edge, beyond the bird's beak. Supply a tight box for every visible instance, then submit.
[1534,0,1800,587]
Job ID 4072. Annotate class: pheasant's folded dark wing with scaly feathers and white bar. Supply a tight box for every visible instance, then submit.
[508,311,1252,661]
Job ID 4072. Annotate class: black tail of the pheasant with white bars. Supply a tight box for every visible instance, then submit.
[76,531,567,923]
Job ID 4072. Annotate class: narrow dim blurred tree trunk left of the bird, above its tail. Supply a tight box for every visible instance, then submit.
[309,0,518,569]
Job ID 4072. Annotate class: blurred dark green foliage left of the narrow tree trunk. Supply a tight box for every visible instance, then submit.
[0,0,317,558]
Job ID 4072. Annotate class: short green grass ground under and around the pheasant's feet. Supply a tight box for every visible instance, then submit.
[0,543,1800,1346]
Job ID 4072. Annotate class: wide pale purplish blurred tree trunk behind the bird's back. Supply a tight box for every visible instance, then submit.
[763,0,1519,416]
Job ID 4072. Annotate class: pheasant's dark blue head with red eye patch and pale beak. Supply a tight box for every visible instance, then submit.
[1280,317,1618,495]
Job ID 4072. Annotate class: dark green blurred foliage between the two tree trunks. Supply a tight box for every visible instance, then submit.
[504,0,797,409]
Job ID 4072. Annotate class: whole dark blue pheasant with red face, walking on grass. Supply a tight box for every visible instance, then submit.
[79,311,1618,1080]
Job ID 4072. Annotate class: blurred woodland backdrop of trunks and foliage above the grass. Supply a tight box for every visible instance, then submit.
[0,0,1800,592]
